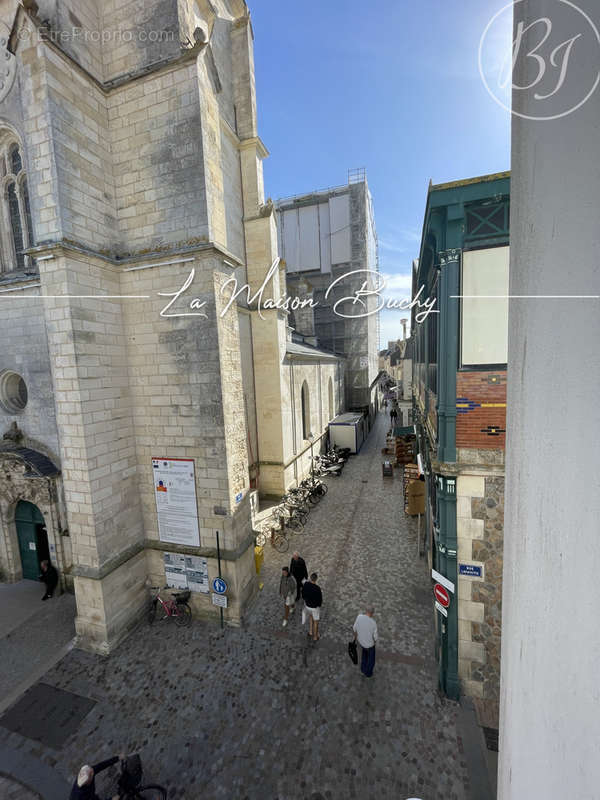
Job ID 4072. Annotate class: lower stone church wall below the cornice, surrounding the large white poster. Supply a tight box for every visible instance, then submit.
[122,254,248,549]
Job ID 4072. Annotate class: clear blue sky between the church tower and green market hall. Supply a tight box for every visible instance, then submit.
[248,0,510,344]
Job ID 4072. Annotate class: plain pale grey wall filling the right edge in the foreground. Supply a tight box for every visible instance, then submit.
[498,0,600,800]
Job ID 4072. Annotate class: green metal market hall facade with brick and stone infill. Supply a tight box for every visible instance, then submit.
[411,173,510,704]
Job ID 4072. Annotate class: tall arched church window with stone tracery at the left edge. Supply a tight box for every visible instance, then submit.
[0,131,34,272]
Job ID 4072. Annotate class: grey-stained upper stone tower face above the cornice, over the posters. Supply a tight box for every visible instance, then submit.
[108,63,208,254]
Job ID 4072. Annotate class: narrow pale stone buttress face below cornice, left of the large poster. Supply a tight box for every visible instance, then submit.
[40,250,142,573]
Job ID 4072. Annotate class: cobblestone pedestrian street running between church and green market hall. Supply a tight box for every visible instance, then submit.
[0,417,478,800]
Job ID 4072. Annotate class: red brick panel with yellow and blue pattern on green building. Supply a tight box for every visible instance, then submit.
[456,370,506,449]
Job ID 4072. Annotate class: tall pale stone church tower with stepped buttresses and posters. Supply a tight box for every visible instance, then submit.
[0,0,286,652]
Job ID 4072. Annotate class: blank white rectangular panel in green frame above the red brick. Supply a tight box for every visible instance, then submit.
[461,247,509,366]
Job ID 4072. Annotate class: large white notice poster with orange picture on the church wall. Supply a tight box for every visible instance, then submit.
[152,458,200,547]
